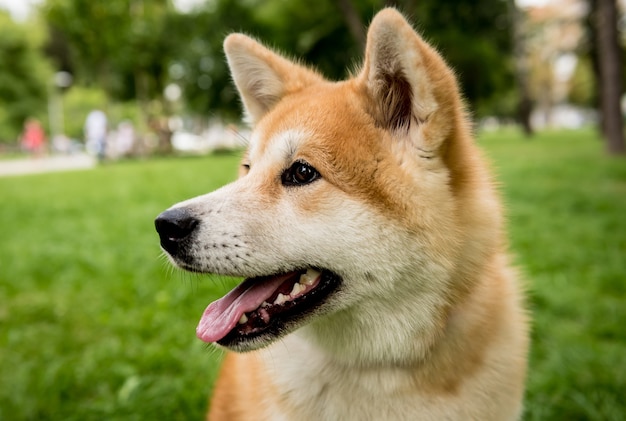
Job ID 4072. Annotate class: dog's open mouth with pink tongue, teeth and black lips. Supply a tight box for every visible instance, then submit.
[196,268,341,347]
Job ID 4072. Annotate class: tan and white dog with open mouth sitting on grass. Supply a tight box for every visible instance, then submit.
[155,9,529,421]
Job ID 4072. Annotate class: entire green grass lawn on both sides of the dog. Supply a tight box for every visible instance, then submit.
[0,131,626,420]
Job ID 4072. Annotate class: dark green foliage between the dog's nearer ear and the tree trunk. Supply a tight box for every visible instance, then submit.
[393,0,516,117]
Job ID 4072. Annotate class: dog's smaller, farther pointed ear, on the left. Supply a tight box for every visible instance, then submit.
[224,34,323,124]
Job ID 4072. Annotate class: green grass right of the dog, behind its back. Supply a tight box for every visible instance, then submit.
[481,131,626,421]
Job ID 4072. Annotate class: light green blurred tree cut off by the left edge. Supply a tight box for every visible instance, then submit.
[0,11,52,143]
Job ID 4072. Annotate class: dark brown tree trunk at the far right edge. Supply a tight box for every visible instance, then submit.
[594,0,626,155]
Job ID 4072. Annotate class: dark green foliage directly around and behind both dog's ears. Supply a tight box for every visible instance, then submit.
[170,0,515,120]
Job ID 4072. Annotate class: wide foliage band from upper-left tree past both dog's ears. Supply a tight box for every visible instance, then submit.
[33,0,513,135]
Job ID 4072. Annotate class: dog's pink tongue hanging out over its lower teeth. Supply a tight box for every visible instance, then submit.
[196,272,297,342]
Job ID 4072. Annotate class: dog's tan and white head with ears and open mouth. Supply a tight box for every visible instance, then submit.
[156,9,493,358]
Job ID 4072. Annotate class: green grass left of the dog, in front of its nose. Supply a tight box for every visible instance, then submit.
[0,155,238,420]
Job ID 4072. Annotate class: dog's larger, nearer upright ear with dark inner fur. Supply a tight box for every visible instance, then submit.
[359,8,462,151]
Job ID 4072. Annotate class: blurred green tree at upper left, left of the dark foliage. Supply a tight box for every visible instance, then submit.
[43,0,178,150]
